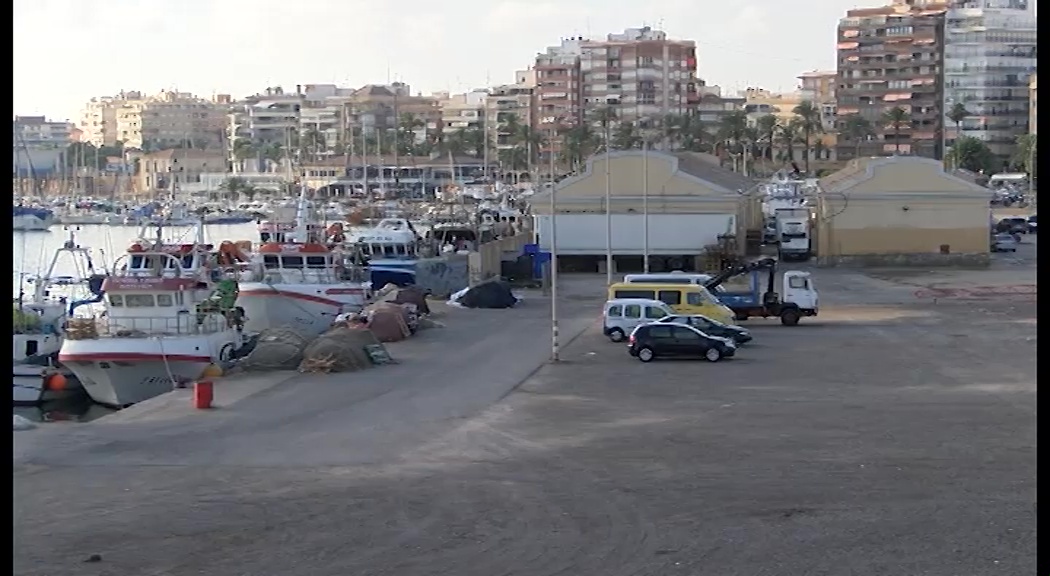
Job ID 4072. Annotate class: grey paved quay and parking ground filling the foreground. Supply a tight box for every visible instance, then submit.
[15,264,1035,576]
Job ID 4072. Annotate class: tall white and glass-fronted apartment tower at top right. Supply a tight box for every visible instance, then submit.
[944,0,1036,162]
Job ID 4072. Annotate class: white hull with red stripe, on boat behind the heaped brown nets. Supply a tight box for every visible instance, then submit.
[237,282,368,336]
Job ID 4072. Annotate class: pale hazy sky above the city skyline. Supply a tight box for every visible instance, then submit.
[14,0,869,121]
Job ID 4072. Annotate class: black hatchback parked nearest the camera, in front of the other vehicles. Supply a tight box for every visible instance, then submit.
[627,323,736,362]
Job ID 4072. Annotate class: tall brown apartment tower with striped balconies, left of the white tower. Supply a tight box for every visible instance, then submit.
[835,0,948,159]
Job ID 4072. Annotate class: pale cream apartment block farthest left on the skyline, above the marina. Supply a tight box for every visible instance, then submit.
[80,90,225,150]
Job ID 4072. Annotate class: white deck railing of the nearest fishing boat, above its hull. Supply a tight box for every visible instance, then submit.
[65,312,231,340]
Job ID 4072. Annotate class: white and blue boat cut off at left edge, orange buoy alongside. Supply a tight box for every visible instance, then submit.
[12,233,105,405]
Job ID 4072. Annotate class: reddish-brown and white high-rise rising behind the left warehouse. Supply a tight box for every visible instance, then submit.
[536,26,699,157]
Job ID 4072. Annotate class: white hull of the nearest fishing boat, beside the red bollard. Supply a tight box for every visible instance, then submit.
[59,329,244,408]
